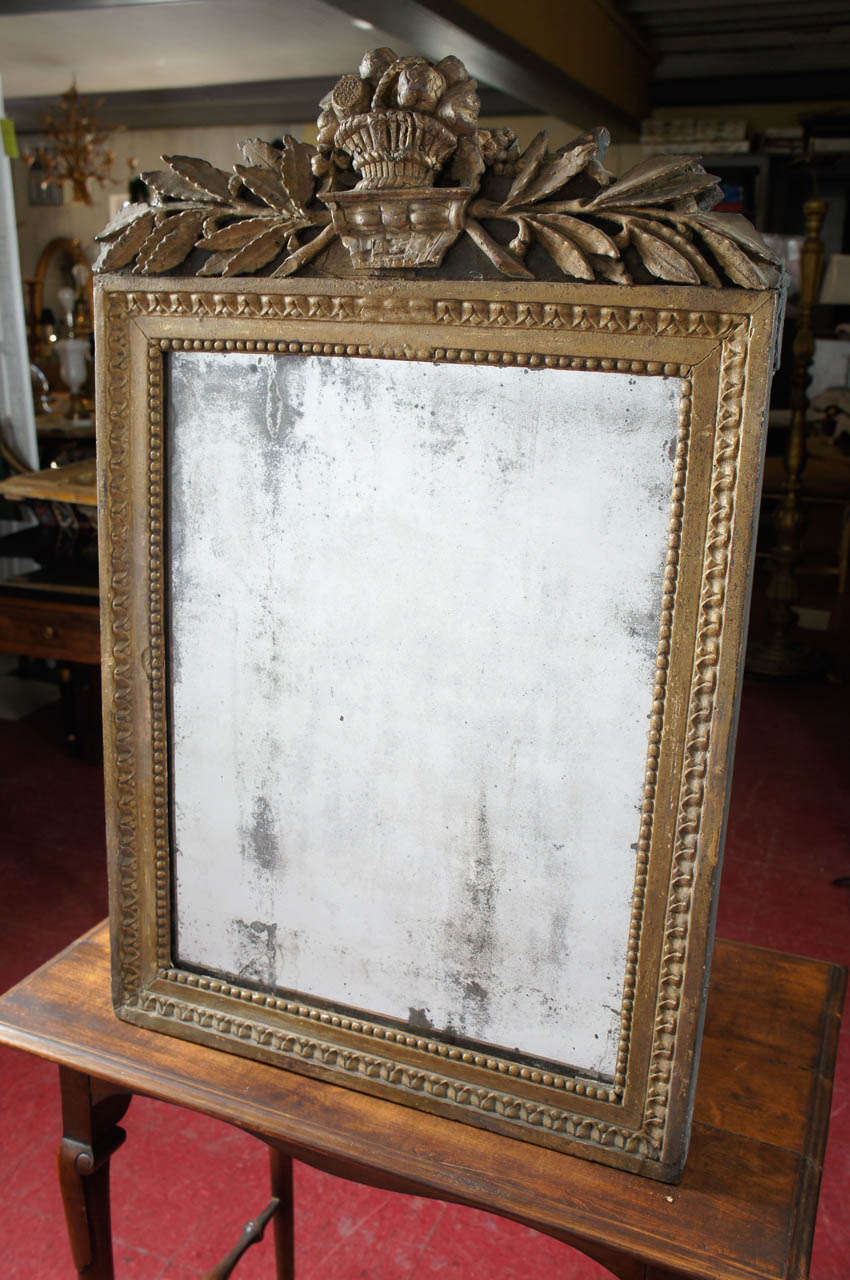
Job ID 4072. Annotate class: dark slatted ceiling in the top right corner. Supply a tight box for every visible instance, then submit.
[618,0,850,106]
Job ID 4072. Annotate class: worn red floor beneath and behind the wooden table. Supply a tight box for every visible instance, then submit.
[0,665,850,1280]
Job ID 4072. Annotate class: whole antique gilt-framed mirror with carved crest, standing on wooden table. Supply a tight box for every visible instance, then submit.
[96,50,778,1180]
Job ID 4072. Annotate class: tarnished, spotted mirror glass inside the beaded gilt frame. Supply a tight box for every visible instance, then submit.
[166,352,681,1079]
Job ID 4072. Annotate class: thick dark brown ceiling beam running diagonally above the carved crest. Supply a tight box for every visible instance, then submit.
[322,0,650,128]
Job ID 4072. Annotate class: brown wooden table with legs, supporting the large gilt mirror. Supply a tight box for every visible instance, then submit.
[0,925,845,1280]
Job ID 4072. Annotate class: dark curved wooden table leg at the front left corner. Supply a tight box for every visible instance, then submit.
[58,1066,132,1280]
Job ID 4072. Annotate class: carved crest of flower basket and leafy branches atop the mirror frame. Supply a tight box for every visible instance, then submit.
[96,49,777,289]
